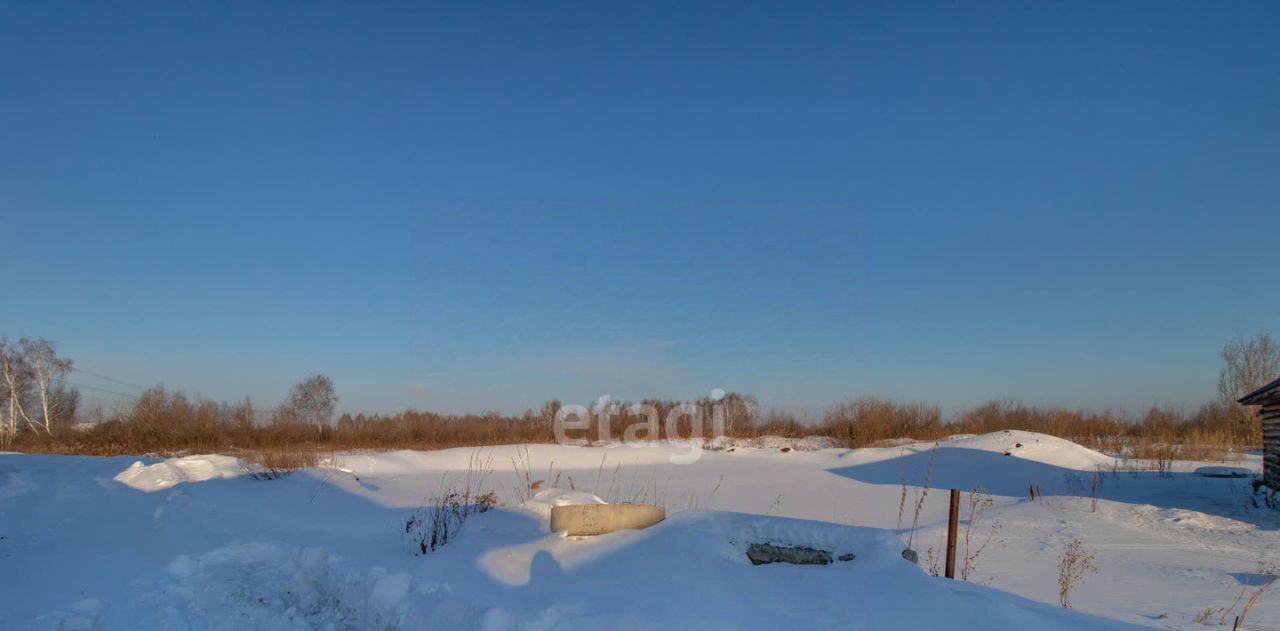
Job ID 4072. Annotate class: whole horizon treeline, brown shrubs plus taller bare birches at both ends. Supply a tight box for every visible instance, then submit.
[0,334,1280,459]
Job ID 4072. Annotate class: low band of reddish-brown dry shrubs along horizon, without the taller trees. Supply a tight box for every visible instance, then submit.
[0,387,1261,457]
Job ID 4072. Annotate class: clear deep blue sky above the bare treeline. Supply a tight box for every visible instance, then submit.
[0,1,1280,413]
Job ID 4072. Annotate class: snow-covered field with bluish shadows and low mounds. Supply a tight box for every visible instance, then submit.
[0,431,1280,630]
